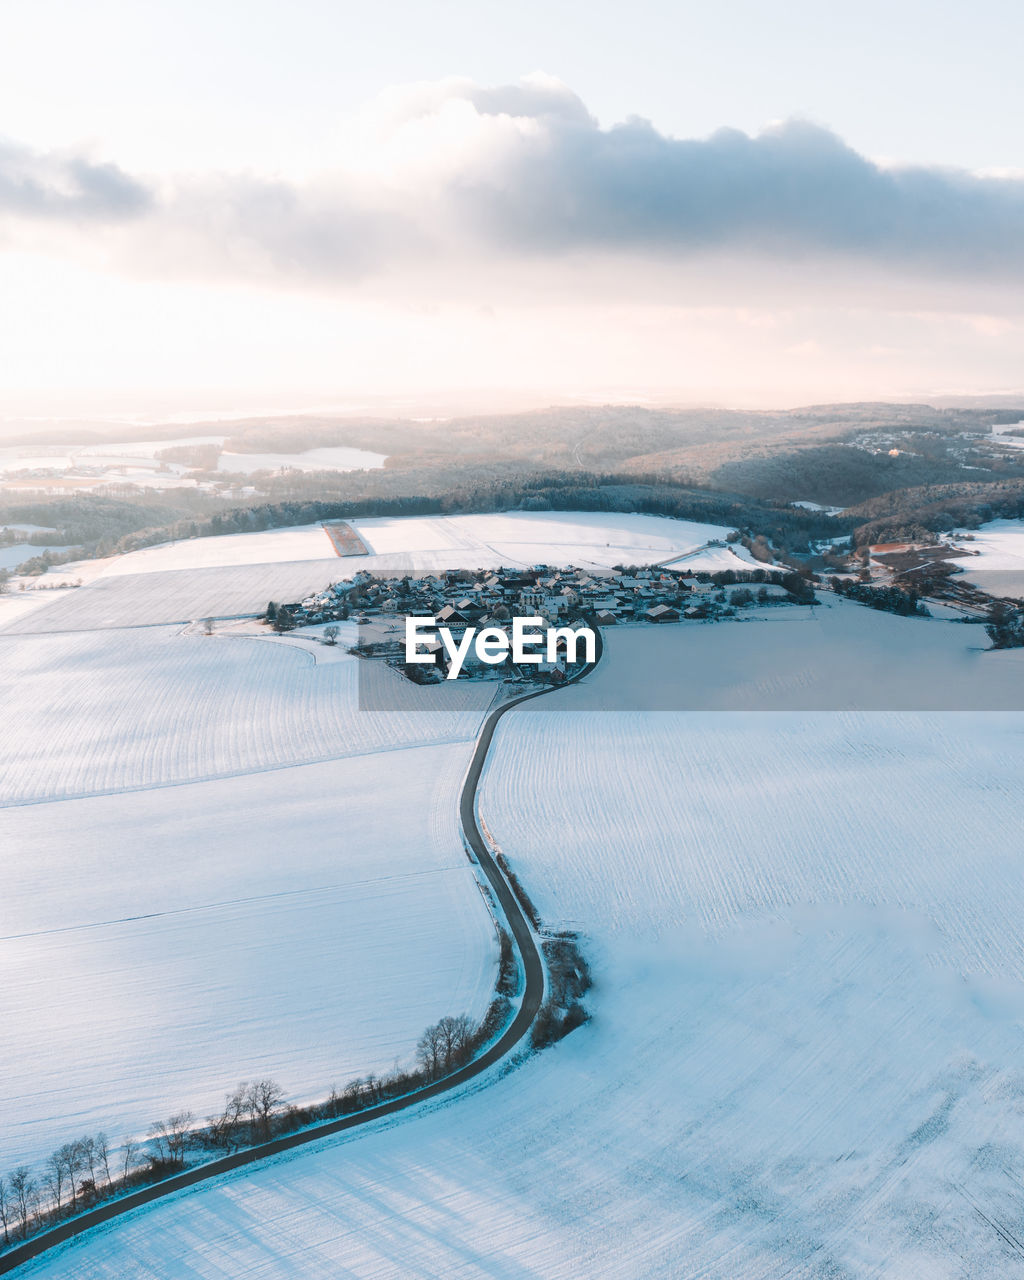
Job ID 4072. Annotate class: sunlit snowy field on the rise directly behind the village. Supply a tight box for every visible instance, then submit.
[0,512,746,634]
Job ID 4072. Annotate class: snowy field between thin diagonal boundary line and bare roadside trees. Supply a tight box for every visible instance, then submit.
[0,742,497,1167]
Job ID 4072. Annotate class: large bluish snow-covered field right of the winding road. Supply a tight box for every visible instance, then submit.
[26,603,1024,1280]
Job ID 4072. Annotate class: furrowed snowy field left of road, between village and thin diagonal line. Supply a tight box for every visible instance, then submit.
[0,627,493,805]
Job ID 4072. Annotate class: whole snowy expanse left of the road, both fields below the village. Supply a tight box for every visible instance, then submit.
[0,619,497,1171]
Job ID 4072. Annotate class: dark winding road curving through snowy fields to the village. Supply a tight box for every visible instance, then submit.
[0,627,604,1275]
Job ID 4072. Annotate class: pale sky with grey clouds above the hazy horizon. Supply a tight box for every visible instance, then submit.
[0,0,1024,424]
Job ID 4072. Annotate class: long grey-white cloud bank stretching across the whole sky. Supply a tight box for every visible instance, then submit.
[0,76,1024,285]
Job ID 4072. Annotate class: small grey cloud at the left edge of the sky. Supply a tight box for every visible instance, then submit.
[0,140,150,220]
